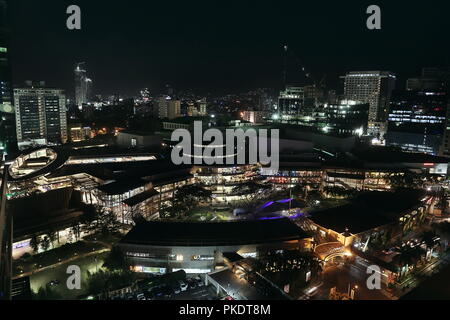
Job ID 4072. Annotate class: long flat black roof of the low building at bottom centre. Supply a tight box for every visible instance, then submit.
[120,218,309,246]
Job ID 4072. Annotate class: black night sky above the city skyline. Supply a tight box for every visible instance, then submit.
[6,0,450,95]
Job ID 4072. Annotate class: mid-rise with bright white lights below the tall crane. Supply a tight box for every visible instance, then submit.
[277,86,305,121]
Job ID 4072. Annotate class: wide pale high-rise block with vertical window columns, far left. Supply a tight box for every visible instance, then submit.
[14,81,67,149]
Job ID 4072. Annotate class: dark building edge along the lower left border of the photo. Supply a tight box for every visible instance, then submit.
[0,165,13,300]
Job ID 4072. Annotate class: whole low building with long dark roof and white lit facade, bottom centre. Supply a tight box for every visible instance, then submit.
[118,218,312,274]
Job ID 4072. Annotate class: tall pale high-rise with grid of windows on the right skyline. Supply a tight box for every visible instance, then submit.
[342,71,396,138]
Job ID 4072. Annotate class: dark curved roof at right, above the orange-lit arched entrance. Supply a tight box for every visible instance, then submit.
[310,190,424,234]
